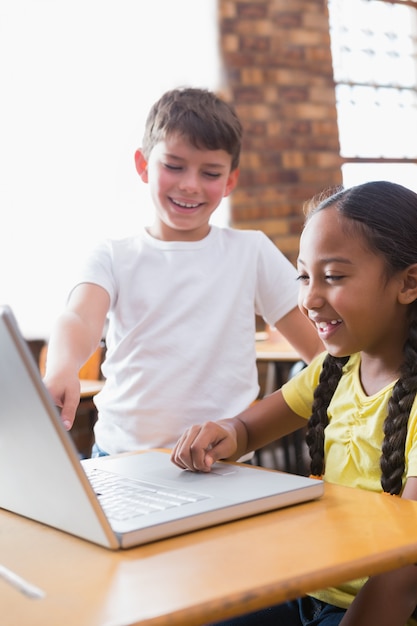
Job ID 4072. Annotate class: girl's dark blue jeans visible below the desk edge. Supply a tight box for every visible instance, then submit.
[211,596,346,626]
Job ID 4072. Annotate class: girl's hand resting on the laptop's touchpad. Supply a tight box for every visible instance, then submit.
[171,422,237,472]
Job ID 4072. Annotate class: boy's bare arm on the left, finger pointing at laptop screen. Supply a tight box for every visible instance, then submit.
[44,283,110,429]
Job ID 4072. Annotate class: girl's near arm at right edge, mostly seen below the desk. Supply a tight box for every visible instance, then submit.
[340,477,417,626]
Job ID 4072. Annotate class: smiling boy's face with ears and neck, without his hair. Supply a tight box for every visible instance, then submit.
[136,134,238,241]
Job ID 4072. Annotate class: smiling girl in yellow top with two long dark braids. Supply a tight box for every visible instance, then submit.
[172,181,417,626]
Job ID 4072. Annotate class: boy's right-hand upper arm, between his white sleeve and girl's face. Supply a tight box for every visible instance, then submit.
[275,307,325,363]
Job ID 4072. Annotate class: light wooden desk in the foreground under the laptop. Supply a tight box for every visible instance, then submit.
[0,472,417,626]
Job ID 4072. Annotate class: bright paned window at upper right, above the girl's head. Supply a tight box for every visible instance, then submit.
[328,0,417,191]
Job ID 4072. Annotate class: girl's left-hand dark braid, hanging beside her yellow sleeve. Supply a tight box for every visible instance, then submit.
[306,354,349,476]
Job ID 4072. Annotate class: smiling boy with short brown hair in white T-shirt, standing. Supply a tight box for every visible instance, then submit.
[45,89,320,454]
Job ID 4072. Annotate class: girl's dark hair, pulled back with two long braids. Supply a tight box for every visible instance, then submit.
[306,181,417,494]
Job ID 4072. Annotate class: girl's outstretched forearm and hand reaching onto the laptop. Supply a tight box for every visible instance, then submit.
[171,390,306,472]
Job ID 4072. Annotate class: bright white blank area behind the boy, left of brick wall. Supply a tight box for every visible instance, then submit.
[0,0,227,338]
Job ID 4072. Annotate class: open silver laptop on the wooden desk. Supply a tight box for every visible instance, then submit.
[0,305,324,550]
